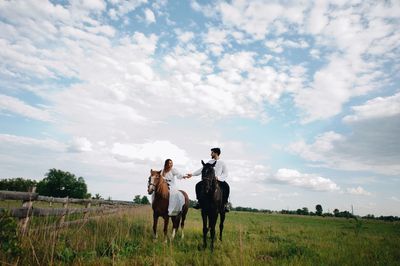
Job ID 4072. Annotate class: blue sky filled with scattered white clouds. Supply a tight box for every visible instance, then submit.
[0,0,400,216]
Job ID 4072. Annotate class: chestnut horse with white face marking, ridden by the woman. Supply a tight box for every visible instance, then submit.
[147,170,189,241]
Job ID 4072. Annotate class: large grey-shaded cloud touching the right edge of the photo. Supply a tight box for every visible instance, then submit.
[289,105,400,175]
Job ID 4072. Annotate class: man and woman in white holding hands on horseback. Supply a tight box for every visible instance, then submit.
[161,148,229,216]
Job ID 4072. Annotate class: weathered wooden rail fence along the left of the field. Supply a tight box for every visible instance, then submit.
[0,189,139,234]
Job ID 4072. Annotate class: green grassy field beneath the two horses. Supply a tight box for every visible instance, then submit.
[0,206,400,265]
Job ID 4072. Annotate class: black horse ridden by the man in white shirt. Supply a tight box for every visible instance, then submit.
[200,161,225,251]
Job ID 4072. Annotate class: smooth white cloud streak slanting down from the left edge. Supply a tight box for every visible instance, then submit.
[0,94,51,122]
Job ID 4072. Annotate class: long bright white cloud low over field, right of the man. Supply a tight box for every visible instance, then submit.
[273,168,340,191]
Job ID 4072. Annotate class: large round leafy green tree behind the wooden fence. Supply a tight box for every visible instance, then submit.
[36,168,90,199]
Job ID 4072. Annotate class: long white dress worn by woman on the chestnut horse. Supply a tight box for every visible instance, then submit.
[162,168,185,216]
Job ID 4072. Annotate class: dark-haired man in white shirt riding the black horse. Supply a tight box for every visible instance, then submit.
[187,148,230,212]
